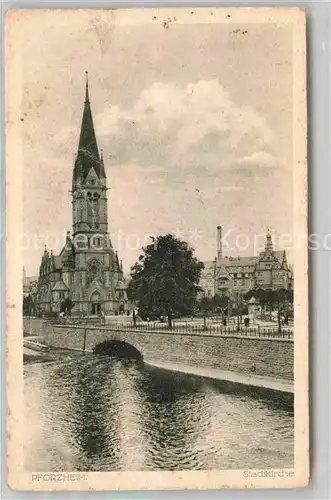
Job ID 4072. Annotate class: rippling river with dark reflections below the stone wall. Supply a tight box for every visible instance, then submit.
[24,355,294,472]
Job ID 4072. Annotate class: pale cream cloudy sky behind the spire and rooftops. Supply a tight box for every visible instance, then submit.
[21,9,293,275]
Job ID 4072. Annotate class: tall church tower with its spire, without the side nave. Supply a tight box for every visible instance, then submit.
[70,72,123,315]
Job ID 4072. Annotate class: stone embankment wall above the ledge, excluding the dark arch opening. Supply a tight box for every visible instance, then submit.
[24,319,294,380]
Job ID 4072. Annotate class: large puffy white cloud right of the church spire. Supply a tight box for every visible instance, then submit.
[91,80,273,176]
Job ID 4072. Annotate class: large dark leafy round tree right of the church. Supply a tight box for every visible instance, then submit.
[127,234,203,328]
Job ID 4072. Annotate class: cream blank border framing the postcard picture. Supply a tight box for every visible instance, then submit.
[5,7,309,491]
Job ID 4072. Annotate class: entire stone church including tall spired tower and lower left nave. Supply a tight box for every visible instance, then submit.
[37,73,127,316]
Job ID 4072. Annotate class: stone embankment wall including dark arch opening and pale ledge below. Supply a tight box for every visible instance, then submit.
[23,318,293,392]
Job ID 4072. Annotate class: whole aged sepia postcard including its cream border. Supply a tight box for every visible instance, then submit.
[6,8,309,491]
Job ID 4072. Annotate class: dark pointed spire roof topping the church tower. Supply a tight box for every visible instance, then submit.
[73,71,101,184]
